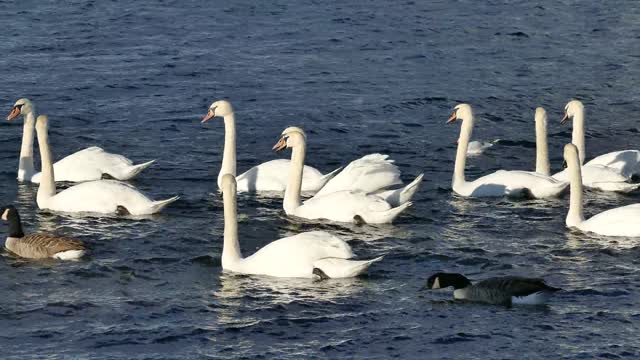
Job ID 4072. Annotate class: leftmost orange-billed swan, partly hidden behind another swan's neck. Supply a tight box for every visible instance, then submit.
[7,98,155,184]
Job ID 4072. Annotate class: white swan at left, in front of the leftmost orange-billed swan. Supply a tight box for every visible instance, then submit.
[36,115,178,215]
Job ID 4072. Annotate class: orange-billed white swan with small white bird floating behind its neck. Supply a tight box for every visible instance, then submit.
[447,104,567,198]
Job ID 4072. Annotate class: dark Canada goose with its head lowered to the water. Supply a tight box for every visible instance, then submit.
[425,272,561,306]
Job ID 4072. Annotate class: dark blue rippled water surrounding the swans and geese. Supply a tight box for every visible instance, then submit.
[0,0,640,359]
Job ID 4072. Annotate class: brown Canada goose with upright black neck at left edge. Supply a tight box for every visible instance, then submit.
[0,205,86,260]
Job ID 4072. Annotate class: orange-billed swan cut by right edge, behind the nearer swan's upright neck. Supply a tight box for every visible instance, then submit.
[561,100,640,178]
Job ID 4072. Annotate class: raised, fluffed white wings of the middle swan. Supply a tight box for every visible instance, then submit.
[316,154,402,195]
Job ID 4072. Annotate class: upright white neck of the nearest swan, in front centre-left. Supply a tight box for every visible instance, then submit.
[222,180,242,269]
